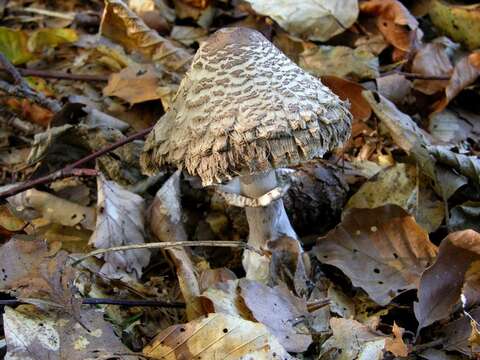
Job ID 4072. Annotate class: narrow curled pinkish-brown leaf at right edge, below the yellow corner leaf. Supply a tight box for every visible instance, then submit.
[433,51,480,112]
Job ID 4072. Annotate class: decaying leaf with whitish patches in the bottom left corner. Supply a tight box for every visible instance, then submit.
[3,305,137,360]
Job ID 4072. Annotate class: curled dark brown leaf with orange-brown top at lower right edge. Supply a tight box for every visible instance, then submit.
[414,230,480,330]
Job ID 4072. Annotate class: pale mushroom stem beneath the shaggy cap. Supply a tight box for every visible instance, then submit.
[240,170,300,282]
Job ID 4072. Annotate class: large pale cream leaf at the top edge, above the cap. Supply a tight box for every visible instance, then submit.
[248,0,358,41]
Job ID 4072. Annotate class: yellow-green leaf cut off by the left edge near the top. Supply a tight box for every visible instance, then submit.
[0,26,33,65]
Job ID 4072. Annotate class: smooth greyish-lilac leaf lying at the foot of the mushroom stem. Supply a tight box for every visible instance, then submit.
[239,279,312,352]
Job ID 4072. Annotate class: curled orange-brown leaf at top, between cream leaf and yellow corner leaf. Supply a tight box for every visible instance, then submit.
[360,0,421,52]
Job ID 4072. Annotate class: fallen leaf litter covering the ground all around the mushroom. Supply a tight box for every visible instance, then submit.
[0,0,480,360]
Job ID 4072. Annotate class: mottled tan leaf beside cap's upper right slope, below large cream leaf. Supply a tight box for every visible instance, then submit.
[299,45,379,80]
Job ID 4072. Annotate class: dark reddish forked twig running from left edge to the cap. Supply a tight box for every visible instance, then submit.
[0,127,153,200]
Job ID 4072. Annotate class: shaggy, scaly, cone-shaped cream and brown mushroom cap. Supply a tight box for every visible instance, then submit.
[140,28,351,186]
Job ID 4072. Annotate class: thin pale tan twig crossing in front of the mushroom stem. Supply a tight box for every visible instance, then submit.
[72,240,265,266]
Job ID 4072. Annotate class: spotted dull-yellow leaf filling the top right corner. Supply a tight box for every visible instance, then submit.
[429,0,480,50]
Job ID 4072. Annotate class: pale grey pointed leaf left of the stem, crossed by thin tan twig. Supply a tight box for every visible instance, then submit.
[90,176,150,279]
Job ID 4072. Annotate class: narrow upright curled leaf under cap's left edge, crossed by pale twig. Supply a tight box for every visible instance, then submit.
[148,170,204,320]
